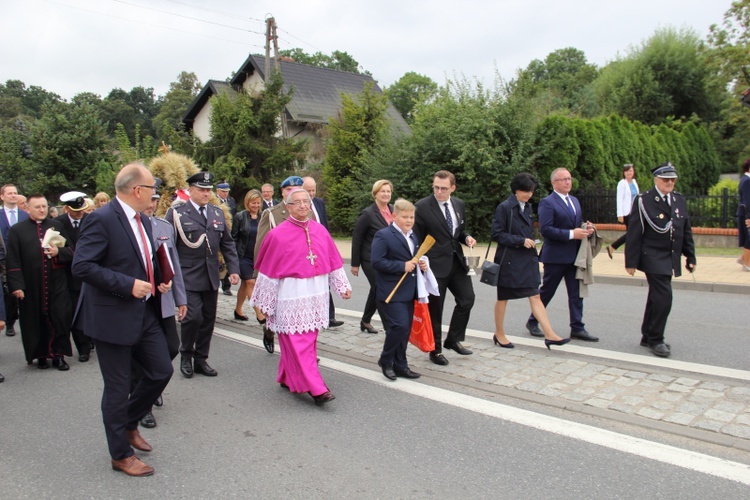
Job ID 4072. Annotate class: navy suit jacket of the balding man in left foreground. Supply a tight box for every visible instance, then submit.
[73,198,161,345]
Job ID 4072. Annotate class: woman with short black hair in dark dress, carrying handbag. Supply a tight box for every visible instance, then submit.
[492,172,570,349]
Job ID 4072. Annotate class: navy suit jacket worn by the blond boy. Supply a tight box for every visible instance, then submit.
[370,224,419,302]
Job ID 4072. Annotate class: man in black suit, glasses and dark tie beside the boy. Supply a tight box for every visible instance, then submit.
[415,170,477,365]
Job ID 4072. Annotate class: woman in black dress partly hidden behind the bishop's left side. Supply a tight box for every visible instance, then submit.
[232,189,265,324]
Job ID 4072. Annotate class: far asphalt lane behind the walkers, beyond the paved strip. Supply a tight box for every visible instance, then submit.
[342,265,750,370]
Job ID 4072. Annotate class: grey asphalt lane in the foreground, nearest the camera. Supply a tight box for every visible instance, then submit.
[0,326,750,499]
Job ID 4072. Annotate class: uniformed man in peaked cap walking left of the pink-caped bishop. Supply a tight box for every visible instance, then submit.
[166,172,240,378]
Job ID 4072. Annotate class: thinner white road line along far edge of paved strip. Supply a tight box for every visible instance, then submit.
[336,307,750,382]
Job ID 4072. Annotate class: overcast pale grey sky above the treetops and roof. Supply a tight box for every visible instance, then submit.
[0,0,731,99]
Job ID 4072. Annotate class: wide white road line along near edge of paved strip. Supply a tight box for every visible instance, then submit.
[214,328,750,486]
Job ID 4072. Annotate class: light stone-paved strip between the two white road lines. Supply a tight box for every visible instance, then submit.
[218,292,750,451]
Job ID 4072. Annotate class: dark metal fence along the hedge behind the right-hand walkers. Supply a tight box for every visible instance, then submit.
[572,188,739,228]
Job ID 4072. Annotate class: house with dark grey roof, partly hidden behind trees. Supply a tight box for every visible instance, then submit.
[182,55,409,161]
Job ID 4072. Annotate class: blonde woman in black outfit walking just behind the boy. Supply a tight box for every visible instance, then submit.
[351,179,400,333]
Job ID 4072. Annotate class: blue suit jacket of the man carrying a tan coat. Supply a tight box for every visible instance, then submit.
[539,191,583,264]
